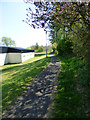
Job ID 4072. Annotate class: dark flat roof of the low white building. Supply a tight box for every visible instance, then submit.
[0,46,34,53]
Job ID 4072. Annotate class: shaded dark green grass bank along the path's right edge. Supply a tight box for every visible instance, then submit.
[53,56,90,118]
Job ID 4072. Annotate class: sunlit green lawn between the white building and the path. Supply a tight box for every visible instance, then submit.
[2,54,51,113]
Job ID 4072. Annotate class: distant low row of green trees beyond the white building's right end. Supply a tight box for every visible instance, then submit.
[27,43,52,52]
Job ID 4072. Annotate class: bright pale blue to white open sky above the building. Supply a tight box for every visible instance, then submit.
[0,0,50,48]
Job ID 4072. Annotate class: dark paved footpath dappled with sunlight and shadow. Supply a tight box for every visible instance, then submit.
[3,55,60,118]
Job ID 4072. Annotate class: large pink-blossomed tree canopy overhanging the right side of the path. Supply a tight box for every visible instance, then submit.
[25,0,90,58]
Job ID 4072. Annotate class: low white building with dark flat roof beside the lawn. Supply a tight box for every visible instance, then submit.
[0,46,34,66]
